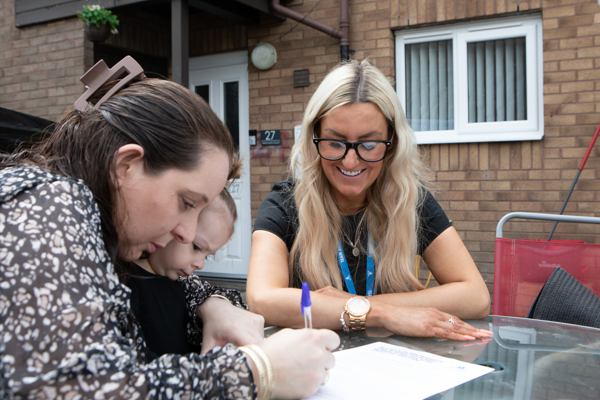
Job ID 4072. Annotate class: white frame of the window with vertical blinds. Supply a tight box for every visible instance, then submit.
[395,14,544,144]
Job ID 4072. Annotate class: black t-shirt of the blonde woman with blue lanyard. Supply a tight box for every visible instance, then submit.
[254,179,451,296]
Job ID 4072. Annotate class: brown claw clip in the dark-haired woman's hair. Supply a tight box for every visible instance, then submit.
[73,56,146,111]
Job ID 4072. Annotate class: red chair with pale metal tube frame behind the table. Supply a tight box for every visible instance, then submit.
[493,212,600,317]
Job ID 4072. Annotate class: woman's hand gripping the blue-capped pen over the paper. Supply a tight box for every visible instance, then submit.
[259,329,340,399]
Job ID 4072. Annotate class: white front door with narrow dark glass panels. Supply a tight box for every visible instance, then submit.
[190,51,252,279]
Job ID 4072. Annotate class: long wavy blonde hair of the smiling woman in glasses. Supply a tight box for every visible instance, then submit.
[289,60,425,293]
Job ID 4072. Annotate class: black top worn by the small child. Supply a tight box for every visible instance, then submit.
[127,265,200,361]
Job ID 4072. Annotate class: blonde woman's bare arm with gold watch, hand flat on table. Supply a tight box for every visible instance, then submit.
[247,231,486,340]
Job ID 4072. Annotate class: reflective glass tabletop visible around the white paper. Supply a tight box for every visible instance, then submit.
[265,316,600,400]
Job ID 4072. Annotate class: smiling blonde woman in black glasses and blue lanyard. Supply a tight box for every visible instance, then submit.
[247,61,490,340]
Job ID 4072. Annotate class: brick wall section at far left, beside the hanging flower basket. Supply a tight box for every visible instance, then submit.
[0,0,93,120]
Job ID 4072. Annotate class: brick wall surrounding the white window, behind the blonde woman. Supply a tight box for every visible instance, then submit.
[248,0,600,291]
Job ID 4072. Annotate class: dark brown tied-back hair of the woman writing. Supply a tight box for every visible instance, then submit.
[3,79,234,266]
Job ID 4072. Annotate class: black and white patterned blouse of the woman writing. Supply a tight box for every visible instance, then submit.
[0,167,256,399]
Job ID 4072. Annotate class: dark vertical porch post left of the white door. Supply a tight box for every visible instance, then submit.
[171,0,190,87]
